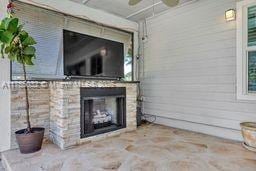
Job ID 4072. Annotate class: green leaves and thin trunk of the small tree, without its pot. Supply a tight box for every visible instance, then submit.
[0,15,36,133]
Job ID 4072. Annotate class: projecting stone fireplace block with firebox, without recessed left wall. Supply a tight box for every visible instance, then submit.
[50,81,137,149]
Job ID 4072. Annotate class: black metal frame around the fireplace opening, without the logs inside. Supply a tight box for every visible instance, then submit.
[80,87,126,138]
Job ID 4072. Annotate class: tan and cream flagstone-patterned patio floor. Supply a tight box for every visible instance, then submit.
[2,124,256,171]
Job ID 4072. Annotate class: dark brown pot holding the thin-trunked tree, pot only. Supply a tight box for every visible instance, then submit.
[15,128,44,154]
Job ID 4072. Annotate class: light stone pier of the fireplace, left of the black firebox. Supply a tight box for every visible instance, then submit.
[50,82,80,149]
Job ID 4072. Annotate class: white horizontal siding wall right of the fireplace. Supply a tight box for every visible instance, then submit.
[142,0,256,140]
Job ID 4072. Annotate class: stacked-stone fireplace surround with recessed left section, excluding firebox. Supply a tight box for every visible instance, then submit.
[11,80,137,149]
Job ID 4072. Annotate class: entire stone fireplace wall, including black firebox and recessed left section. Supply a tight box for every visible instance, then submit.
[11,80,137,149]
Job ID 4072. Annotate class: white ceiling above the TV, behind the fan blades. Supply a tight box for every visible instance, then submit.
[71,0,191,21]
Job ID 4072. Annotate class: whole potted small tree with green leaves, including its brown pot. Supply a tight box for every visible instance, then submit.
[0,3,44,154]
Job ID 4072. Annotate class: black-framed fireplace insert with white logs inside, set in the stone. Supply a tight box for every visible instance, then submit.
[80,87,126,138]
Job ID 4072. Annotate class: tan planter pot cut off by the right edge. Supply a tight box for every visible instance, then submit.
[240,122,256,149]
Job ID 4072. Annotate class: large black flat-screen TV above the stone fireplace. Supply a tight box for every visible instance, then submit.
[63,30,124,79]
